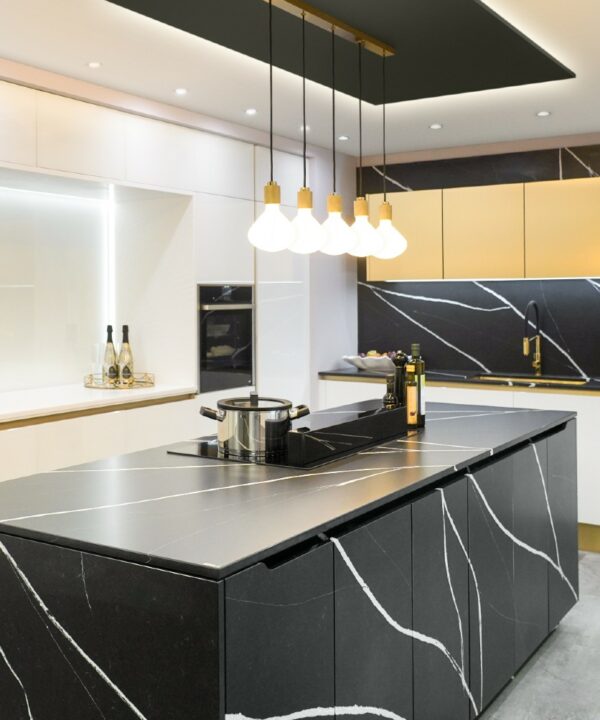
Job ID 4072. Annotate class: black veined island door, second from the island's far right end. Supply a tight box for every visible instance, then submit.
[513,440,552,669]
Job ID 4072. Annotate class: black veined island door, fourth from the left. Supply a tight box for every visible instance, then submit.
[468,456,516,710]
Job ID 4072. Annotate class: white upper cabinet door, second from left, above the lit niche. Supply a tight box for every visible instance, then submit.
[37,92,127,180]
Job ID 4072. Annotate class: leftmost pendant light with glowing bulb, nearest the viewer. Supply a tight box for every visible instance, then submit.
[248,0,293,252]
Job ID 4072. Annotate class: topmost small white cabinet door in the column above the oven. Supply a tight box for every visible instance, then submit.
[194,132,254,200]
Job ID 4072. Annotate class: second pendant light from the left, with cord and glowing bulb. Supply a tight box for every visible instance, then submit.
[289,13,325,255]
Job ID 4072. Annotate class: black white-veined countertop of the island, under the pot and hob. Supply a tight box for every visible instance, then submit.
[0,401,573,579]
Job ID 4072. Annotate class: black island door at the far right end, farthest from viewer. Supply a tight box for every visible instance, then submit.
[548,420,579,630]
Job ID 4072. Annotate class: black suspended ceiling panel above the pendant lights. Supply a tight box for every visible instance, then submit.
[108,0,574,104]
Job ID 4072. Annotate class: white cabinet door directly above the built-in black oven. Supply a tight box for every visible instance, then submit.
[194,193,254,285]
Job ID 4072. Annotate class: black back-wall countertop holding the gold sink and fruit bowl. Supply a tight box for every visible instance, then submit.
[319,366,600,393]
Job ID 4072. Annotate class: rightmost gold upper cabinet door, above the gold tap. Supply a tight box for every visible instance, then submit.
[525,178,600,278]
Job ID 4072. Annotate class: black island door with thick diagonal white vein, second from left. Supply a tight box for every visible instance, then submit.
[332,507,412,720]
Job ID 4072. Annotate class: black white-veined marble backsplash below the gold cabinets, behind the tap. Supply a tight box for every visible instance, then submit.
[358,278,600,378]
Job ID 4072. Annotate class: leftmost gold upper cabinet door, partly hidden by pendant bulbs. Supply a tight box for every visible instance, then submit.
[367,190,443,282]
